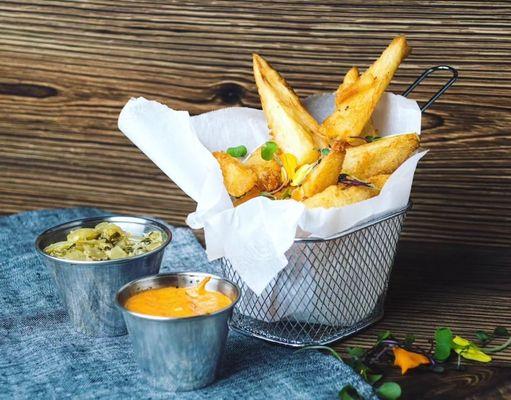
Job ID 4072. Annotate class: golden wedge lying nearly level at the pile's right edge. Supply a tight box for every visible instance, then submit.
[342,133,420,180]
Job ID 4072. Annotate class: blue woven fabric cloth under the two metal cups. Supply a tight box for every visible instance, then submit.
[0,208,376,400]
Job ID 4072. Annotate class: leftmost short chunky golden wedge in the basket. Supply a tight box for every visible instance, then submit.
[213,151,257,197]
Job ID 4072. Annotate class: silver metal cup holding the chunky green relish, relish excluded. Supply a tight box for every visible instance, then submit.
[35,216,172,337]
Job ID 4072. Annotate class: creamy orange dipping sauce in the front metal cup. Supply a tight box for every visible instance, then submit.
[124,277,232,318]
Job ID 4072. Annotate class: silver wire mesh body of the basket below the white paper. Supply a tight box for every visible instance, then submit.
[222,211,405,346]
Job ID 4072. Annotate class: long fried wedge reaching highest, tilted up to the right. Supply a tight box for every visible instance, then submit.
[320,36,410,141]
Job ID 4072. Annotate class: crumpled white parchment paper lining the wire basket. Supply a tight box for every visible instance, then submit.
[119,93,426,295]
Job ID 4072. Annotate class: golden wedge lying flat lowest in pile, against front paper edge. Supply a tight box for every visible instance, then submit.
[303,184,379,208]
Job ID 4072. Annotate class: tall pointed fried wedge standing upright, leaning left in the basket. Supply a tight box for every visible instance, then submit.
[253,54,326,166]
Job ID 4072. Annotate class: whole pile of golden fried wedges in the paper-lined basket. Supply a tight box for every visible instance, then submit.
[213,36,419,208]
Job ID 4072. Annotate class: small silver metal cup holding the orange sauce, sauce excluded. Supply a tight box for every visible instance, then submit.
[116,272,240,392]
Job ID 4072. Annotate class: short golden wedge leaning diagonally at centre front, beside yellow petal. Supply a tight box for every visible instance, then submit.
[291,150,345,201]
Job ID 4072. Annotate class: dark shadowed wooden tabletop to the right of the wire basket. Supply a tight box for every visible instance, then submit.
[333,241,511,400]
